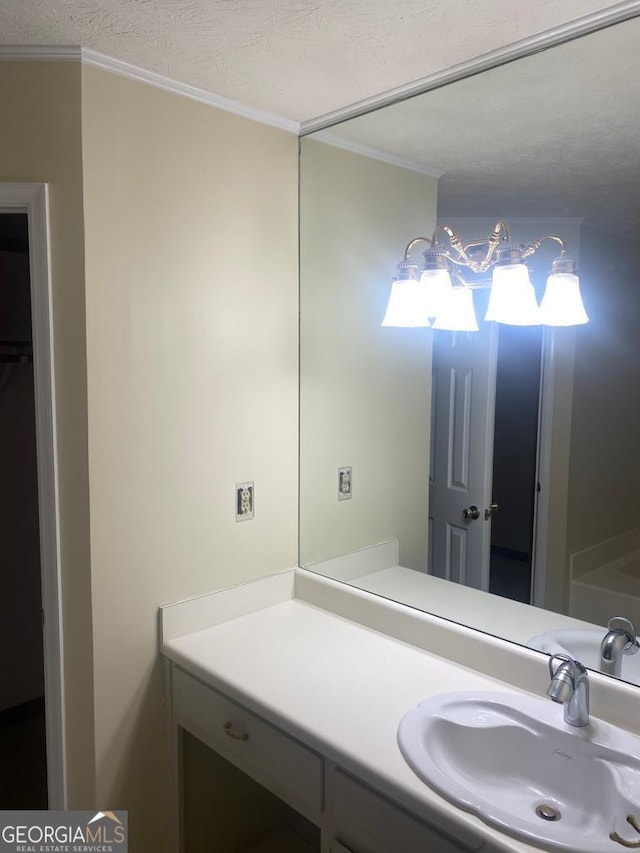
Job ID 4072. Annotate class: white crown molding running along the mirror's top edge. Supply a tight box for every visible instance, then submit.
[300,0,640,136]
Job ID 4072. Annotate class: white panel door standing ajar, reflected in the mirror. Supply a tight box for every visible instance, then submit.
[428,323,498,590]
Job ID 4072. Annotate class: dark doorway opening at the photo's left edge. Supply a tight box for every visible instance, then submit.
[0,213,48,809]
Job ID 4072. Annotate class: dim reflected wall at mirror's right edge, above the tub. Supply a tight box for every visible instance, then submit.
[567,228,640,554]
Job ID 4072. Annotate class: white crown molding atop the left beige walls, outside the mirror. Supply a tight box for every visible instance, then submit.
[0,45,300,135]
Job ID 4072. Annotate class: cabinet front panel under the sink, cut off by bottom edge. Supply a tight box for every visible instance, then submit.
[328,769,481,853]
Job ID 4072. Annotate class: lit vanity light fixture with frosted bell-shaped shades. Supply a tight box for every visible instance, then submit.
[382,220,589,331]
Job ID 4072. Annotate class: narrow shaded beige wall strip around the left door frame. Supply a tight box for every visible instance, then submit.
[0,63,94,808]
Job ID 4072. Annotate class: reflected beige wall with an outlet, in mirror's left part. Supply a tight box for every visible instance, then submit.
[300,139,437,569]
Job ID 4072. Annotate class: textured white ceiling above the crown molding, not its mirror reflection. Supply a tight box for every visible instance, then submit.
[0,0,612,121]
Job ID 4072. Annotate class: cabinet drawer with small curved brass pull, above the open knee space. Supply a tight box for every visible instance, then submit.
[172,666,323,824]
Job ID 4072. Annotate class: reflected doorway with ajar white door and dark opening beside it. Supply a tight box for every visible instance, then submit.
[428,267,546,604]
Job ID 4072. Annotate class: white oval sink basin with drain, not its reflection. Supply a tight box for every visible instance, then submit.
[398,692,640,853]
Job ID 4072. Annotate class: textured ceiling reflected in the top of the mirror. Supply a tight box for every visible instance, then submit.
[318,12,640,235]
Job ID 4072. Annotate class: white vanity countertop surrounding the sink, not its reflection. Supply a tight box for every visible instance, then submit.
[162,568,632,853]
